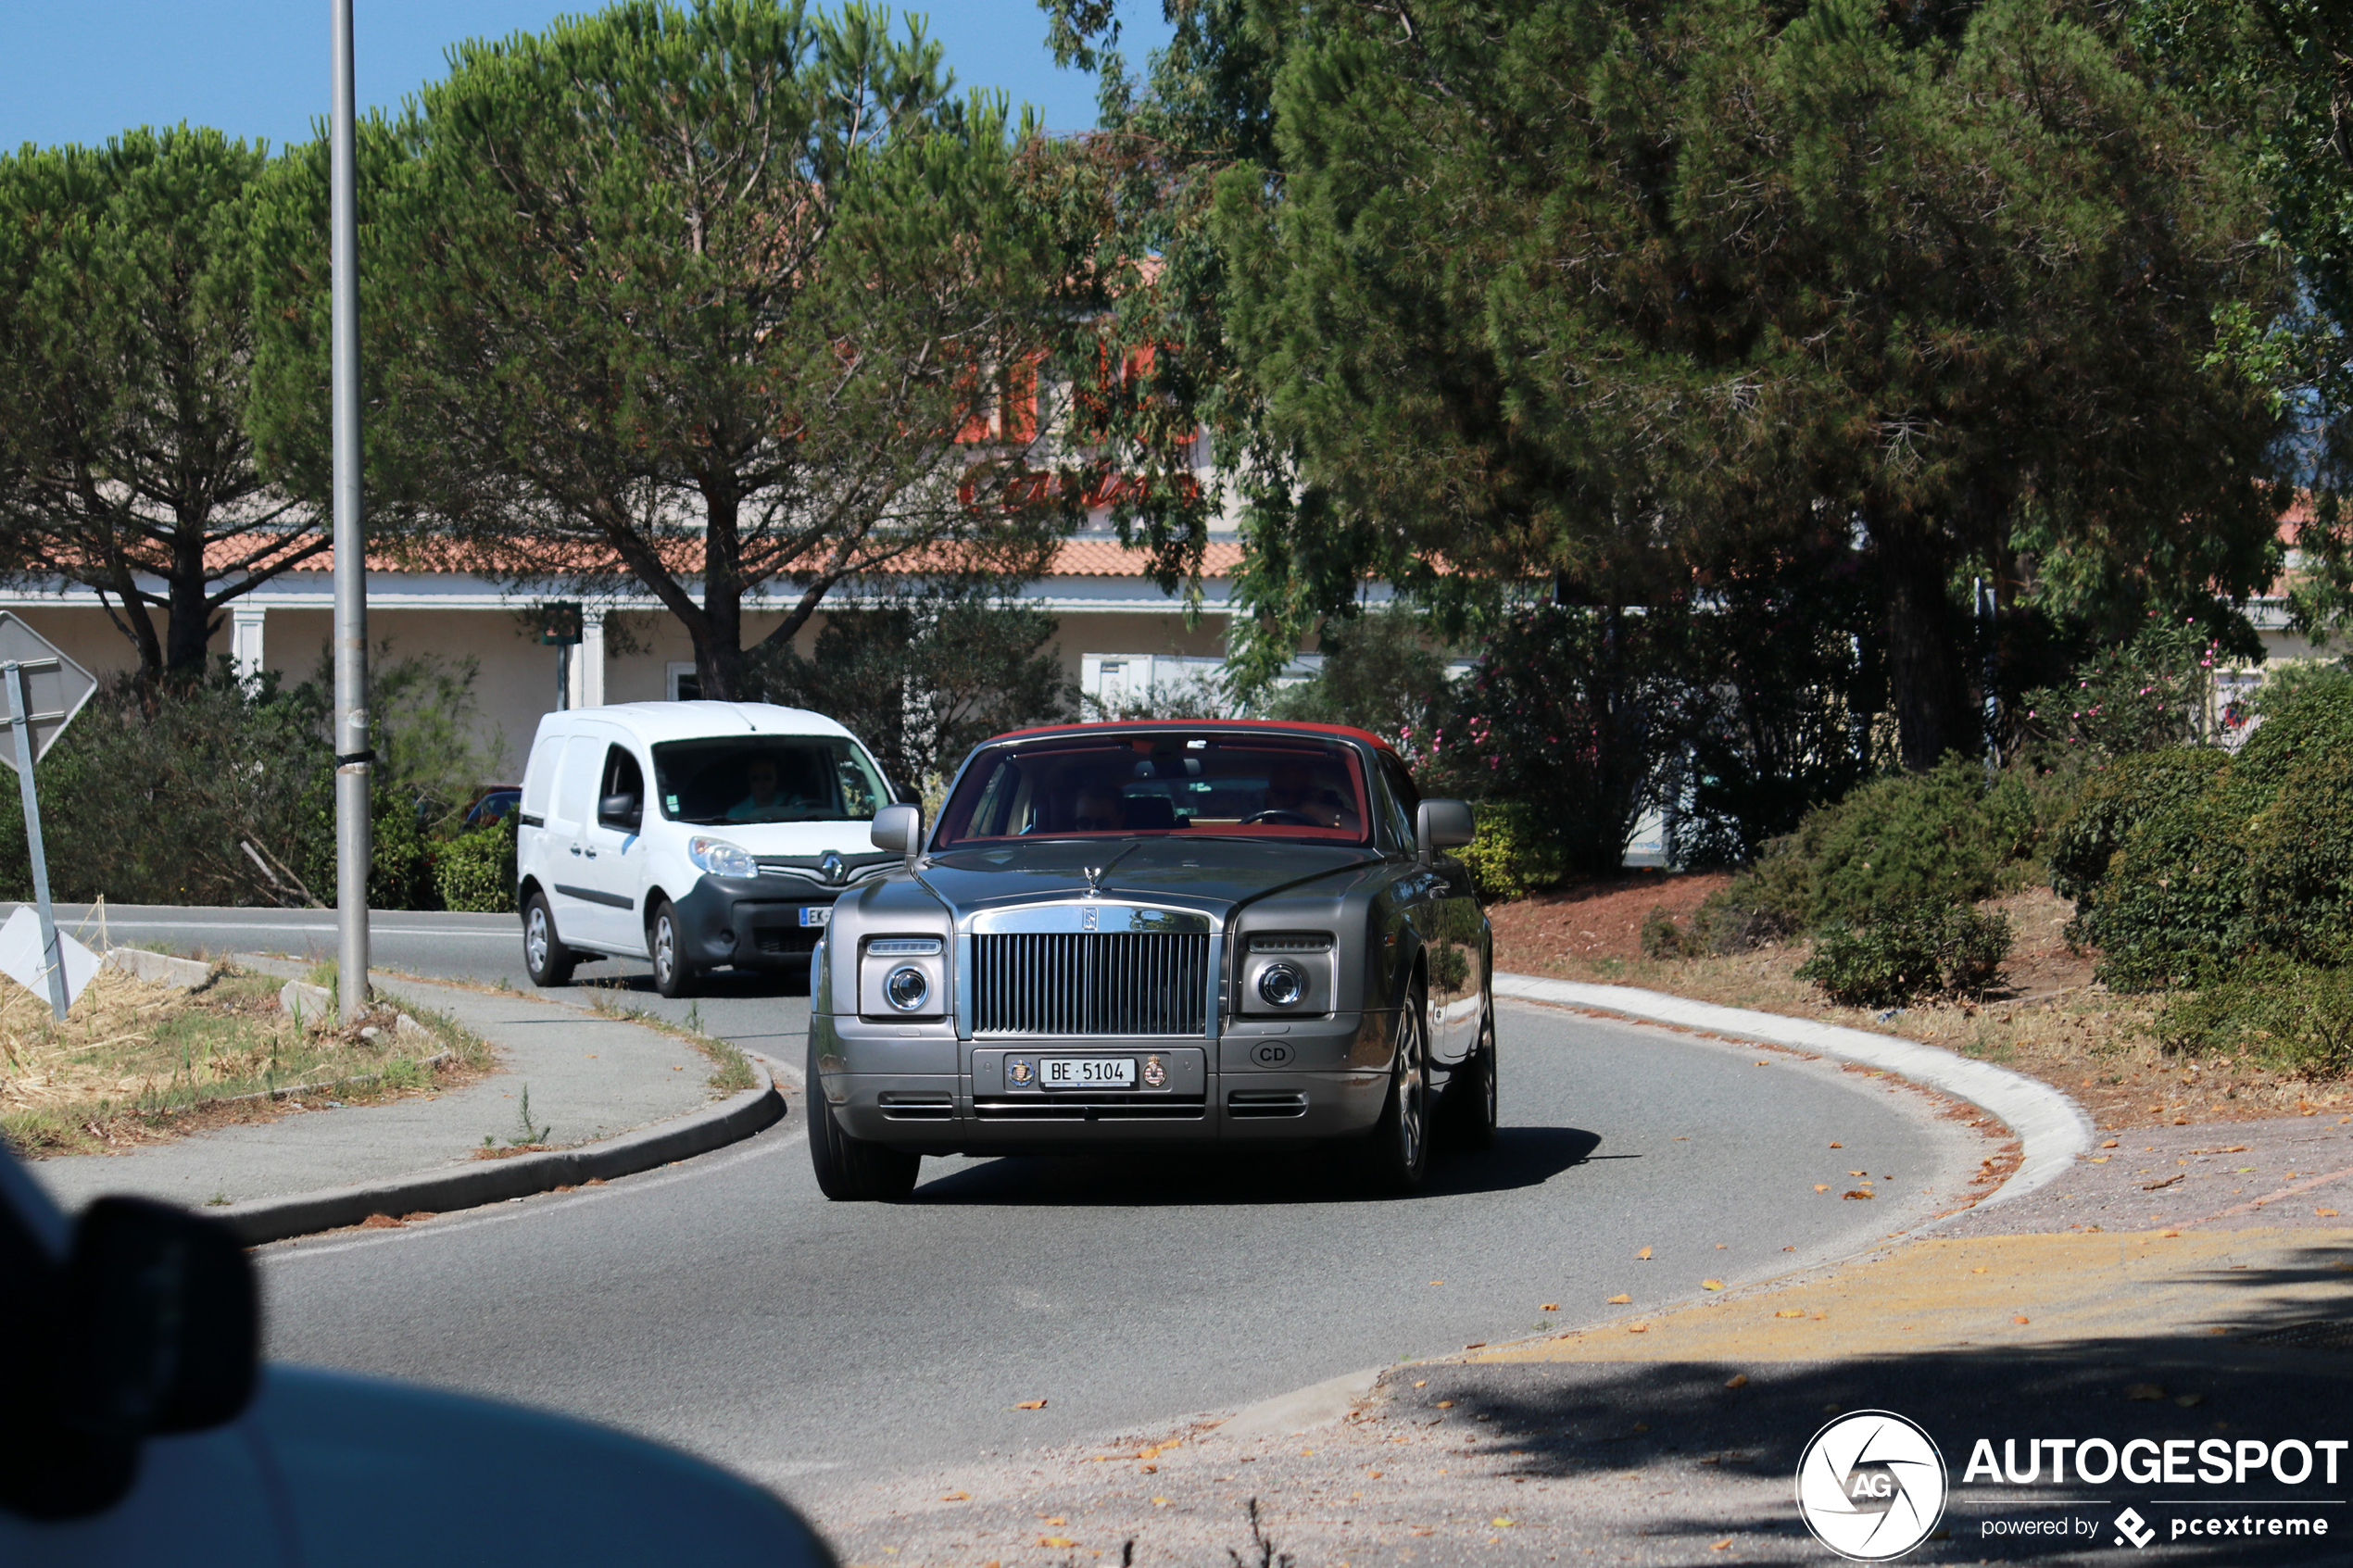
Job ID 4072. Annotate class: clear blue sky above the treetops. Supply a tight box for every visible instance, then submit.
[0,0,1167,150]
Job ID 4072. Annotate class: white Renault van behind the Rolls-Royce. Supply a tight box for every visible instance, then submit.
[515,703,899,997]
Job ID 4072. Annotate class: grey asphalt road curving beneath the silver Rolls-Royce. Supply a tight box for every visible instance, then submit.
[45,909,1988,1507]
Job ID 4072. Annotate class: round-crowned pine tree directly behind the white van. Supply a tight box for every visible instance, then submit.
[261,0,1082,698]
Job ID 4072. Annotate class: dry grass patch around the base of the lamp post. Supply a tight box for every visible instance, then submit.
[0,949,489,1159]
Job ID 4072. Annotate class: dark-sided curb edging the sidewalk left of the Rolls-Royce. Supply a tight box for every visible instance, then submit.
[220,1053,786,1246]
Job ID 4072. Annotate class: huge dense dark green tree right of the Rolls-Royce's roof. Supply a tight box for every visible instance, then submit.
[1056,0,2284,769]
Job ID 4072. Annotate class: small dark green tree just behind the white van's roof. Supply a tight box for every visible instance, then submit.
[746,585,1073,790]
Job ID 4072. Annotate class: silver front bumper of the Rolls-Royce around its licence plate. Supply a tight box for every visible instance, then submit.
[810,1013,1390,1154]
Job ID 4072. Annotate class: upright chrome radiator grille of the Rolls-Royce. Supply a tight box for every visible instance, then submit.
[972,931,1210,1035]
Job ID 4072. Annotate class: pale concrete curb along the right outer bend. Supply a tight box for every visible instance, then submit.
[1494,973,2095,1209]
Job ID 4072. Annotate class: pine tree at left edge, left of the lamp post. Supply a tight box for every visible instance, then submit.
[0,127,327,682]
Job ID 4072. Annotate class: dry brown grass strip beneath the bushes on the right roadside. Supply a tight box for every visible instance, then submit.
[1487,874,2353,1131]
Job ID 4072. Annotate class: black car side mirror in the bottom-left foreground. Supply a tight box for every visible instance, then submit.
[0,1197,261,1519]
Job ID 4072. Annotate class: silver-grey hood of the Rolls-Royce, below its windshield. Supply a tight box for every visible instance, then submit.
[920,837,1381,917]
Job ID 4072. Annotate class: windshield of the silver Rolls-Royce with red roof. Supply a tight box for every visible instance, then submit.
[938,731,1372,847]
